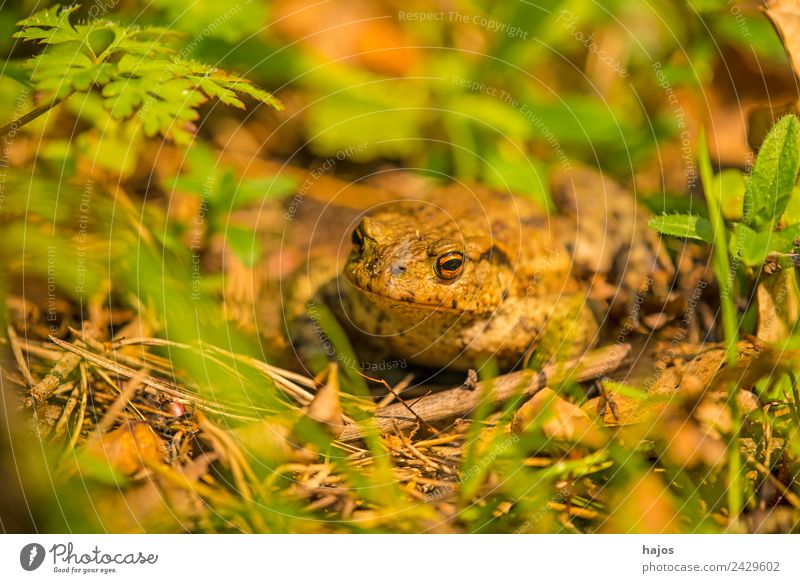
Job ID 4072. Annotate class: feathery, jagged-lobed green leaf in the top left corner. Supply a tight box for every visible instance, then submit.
[14,5,282,144]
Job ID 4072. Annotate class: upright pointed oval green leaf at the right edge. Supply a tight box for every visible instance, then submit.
[743,115,800,231]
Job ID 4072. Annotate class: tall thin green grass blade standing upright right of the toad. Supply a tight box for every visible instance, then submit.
[698,131,744,526]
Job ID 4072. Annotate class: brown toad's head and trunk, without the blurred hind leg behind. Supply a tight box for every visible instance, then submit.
[337,187,598,370]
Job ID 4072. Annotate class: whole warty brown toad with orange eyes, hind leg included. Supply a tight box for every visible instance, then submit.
[282,167,674,370]
